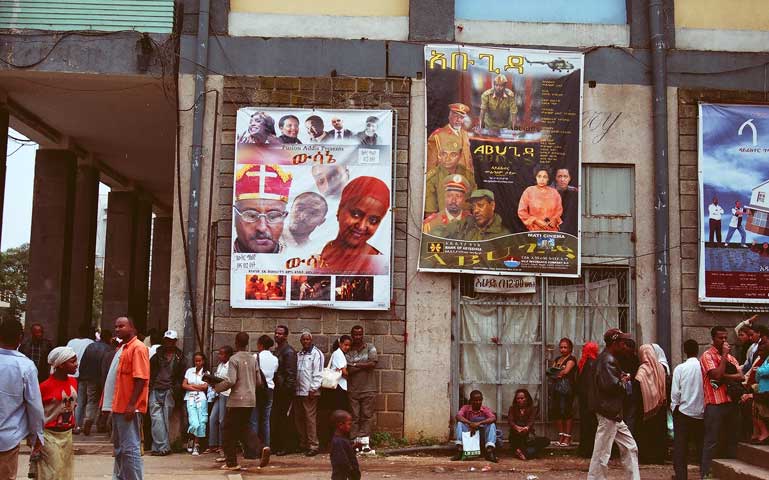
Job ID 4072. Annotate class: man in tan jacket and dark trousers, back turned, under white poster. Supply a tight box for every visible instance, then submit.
[214,332,270,470]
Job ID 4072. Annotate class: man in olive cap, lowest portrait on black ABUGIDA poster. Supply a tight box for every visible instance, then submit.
[445,189,511,242]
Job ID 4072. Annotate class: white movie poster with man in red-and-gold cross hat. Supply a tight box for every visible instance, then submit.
[230,107,393,310]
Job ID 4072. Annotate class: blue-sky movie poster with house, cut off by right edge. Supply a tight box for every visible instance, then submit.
[699,103,769,303]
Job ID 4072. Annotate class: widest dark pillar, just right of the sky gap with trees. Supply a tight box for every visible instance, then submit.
[26,149,77,343]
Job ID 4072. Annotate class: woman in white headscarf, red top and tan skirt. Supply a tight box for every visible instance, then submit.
[36,347,77,480]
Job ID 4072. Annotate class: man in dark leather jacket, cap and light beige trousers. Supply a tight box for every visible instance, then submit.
[587,328,641,480]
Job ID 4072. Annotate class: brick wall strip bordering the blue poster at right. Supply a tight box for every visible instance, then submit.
[678,90,767,346]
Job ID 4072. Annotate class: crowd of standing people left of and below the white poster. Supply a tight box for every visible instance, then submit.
[0,317,377,480]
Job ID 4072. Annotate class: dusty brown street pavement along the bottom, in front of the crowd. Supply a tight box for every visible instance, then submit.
[17,454,680,480]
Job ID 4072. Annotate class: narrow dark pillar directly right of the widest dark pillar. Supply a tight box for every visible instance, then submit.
[66,165,99,338]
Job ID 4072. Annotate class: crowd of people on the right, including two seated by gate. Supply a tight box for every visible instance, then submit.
[452,316,769,480]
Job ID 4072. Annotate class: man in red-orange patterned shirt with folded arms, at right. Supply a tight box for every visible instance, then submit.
[700,326,743,478]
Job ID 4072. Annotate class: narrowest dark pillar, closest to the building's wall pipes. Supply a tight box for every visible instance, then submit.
[147,216,173,330]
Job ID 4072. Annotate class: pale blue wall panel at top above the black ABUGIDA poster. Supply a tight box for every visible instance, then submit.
[454,0,627,25]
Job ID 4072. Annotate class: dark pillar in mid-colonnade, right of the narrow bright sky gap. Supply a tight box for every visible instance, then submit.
[101,191,152,332]
